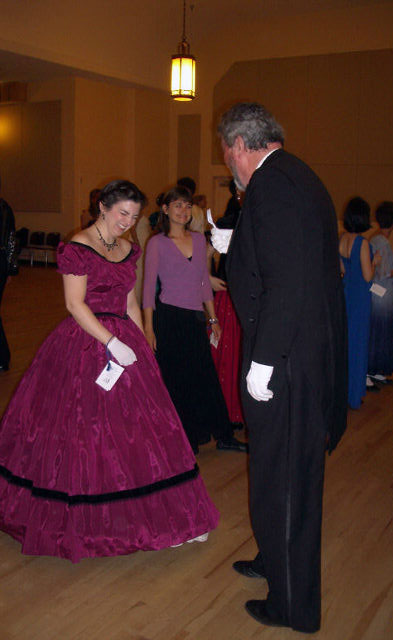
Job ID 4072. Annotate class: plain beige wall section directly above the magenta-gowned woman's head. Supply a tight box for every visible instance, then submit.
[75,78,169,222]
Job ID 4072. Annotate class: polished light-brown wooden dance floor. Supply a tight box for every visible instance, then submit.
[0,267,393,640]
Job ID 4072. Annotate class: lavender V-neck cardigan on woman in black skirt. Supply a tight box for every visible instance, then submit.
[143,232,213,311]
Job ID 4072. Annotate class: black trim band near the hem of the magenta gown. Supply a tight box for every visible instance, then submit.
[0,463,199,506]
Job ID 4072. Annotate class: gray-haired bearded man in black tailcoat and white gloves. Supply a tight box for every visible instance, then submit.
[212,103,347,632]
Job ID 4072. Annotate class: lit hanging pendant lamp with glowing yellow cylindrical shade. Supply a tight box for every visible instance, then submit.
[171,0,195,102]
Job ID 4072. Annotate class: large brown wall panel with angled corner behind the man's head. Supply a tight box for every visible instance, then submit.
[212,50,393,215]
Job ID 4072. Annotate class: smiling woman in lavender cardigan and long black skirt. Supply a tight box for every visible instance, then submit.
[143,186,246,453]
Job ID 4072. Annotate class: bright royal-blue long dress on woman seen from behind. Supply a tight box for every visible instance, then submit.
[341,236,371,409]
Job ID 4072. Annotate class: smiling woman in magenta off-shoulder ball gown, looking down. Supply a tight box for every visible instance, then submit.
[0,180,218,562]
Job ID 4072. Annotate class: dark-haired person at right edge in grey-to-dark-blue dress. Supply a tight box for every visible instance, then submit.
[368,201,393,384]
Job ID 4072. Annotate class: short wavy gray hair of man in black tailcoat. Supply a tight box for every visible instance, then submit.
[218,102,284,151]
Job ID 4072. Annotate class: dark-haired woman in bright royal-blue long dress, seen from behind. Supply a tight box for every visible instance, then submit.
[339,197,381,409]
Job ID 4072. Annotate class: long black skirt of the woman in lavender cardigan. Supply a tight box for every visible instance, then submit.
[154,301,232,449]
